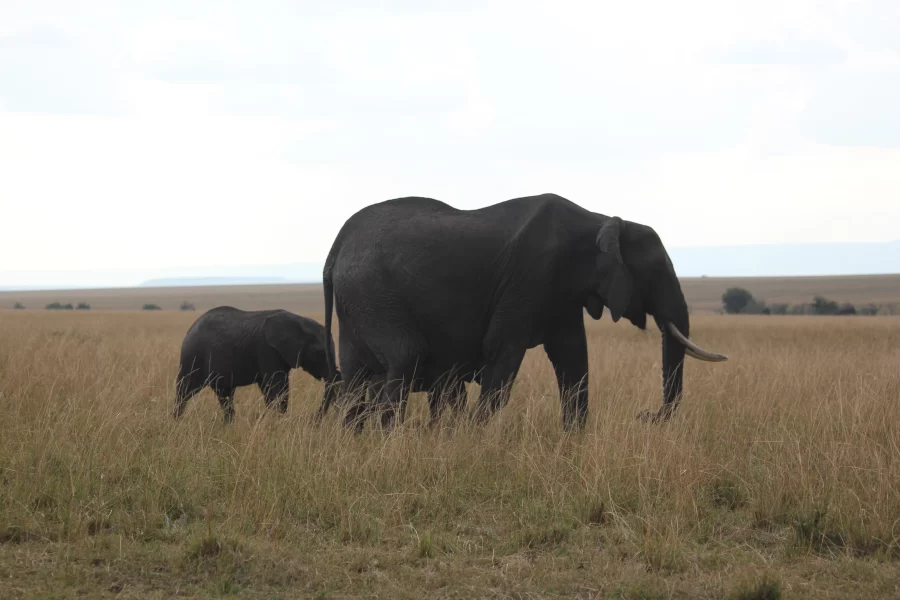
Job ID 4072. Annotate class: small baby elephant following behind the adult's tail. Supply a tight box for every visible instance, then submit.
[172,306,341,423]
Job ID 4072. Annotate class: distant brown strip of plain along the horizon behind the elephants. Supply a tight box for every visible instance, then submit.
[0,275,900,314]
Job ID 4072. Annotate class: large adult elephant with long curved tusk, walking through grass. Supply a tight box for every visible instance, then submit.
[321,194,726,430]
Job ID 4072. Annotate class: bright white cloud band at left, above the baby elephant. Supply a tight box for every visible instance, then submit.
[0,113,342,270]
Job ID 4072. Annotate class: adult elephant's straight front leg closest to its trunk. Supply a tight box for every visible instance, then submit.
[544,316,588,431]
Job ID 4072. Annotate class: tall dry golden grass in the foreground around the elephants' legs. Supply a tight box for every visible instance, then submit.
[0,307,900,599]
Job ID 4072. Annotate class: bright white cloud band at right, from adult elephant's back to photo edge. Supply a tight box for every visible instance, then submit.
[483,144,900,247]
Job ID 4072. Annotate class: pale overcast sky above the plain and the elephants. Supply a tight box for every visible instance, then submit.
[0,0,900,284]
